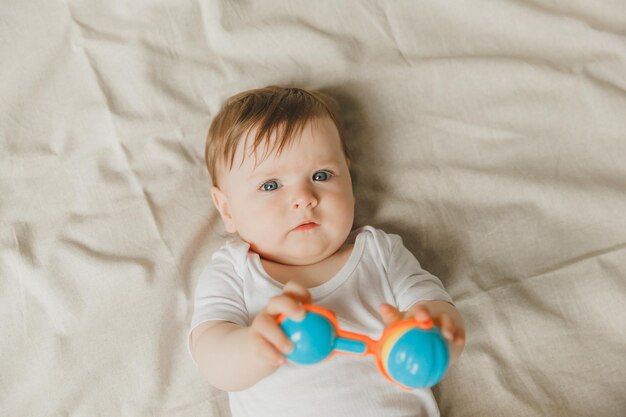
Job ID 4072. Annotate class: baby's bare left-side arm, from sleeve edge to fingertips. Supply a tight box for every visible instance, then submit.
[191,283,310,391]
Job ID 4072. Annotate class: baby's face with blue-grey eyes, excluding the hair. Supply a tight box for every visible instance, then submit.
[213,117,354,265]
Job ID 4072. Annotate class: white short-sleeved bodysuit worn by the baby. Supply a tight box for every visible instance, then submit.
[191,226,452,417]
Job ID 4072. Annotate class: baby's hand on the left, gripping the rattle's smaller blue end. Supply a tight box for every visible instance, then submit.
[250,281,311,367]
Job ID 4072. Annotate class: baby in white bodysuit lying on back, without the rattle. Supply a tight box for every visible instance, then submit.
[189,87,465,417]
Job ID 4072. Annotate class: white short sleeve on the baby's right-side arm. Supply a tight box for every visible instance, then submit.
[387,234,452,311]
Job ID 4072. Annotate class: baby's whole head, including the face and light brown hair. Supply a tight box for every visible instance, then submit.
[205,86,354,265]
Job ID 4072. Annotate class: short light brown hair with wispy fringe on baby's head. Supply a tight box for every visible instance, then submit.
[204,86,349,186]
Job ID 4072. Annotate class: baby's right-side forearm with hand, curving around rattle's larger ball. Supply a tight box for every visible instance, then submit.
[380,300,465,365]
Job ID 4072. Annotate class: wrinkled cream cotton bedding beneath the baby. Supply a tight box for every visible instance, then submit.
[0,0,626,417]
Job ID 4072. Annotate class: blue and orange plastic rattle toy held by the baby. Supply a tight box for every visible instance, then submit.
[277,305,450,390]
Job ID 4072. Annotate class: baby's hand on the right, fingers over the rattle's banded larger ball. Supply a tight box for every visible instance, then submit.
[379,304,465,346]
